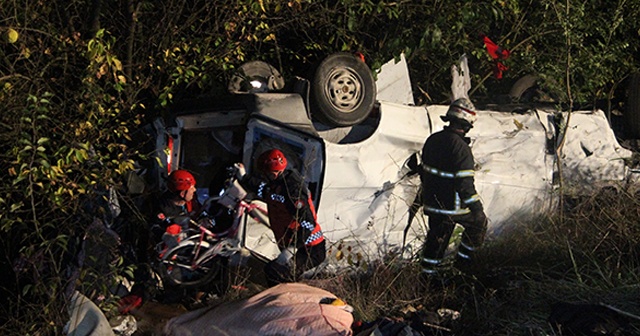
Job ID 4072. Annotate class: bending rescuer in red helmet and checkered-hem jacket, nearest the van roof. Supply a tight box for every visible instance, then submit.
[239,149,326,286]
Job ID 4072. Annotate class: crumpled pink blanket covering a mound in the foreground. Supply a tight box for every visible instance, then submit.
[163,283,353,336]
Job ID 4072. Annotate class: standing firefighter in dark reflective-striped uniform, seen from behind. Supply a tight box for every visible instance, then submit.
[419,98,487,276]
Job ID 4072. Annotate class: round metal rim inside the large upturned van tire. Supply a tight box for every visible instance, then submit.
[325,68,363,113]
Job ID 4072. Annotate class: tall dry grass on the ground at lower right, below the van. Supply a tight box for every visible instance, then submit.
[313,189,640,335]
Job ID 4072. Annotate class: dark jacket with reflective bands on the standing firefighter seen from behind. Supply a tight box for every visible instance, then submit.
[420,127,482,215]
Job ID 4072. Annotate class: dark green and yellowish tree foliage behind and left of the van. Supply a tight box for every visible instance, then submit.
[0,0,640,334]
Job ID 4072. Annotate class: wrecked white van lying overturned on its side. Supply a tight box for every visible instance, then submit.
[146,53,631,264]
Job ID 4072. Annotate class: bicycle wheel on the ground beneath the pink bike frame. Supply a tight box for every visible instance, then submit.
[159,240,224,288]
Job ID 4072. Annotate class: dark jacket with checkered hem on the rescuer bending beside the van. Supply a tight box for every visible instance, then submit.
[242,170,324,249]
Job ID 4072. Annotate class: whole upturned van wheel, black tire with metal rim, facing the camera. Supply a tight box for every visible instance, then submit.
[310,52,376,126]
